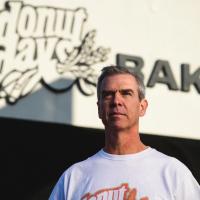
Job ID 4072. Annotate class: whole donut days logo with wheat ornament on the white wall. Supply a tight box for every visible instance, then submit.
[0,1,110,104]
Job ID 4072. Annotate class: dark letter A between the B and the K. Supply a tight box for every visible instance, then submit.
[147,60,178,90]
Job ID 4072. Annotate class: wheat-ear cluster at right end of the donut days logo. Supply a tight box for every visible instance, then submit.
[57,30,110,95]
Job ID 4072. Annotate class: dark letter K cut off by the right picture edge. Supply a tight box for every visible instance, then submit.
[181,64,200,93]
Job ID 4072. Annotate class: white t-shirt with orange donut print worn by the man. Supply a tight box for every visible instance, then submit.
[49,147,200,200]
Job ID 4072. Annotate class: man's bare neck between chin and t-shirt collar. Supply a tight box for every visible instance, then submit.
[104,128,147,155]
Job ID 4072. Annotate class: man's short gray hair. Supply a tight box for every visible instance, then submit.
[97,66,145,101]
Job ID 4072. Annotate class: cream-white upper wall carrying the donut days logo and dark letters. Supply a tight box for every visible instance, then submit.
[0,0,200,139]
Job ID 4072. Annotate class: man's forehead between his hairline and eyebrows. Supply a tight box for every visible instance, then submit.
[101,74,138,90]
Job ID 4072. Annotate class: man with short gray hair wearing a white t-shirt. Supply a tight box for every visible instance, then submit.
[49,66,200,200]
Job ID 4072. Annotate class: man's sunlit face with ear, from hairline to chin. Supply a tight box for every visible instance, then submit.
[97,74,147,130]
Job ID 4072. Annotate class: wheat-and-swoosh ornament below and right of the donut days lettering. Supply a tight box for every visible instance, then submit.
[0,30,110,104]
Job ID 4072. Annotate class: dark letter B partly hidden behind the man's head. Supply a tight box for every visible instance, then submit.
[117,54,144,79]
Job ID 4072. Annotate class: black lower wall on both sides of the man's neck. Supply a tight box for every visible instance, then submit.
[0,118,200,200]
